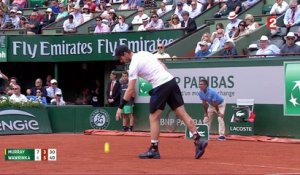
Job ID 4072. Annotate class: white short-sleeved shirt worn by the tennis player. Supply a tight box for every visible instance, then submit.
[128,51,173,88]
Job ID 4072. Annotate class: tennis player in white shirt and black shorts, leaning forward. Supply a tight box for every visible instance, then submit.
[115,45,208,159]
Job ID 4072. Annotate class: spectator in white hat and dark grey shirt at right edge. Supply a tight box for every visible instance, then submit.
[280,32,300,54]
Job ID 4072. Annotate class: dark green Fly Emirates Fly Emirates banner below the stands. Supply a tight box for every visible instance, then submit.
[8,29,184,62]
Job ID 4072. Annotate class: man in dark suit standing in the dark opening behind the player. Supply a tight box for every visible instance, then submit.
[106,71,121,107]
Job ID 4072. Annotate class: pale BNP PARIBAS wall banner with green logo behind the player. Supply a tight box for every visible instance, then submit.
[136,66,284,104]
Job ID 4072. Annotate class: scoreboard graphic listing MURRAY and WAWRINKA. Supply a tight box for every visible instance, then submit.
[5,148,57,161]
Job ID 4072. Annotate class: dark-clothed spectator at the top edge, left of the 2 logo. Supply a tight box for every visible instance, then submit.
[215,0,242,18]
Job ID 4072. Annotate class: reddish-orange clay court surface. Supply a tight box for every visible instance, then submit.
[0,134,300,175]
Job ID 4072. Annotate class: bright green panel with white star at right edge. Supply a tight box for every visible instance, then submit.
[284,62,300,116]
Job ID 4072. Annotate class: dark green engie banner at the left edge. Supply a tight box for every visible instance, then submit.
[0,108,52,135]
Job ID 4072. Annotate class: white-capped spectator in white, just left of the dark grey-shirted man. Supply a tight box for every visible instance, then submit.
[256,35,280,57]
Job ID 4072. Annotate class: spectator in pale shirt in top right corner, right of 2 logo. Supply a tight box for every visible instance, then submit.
[283,0,300,28]
